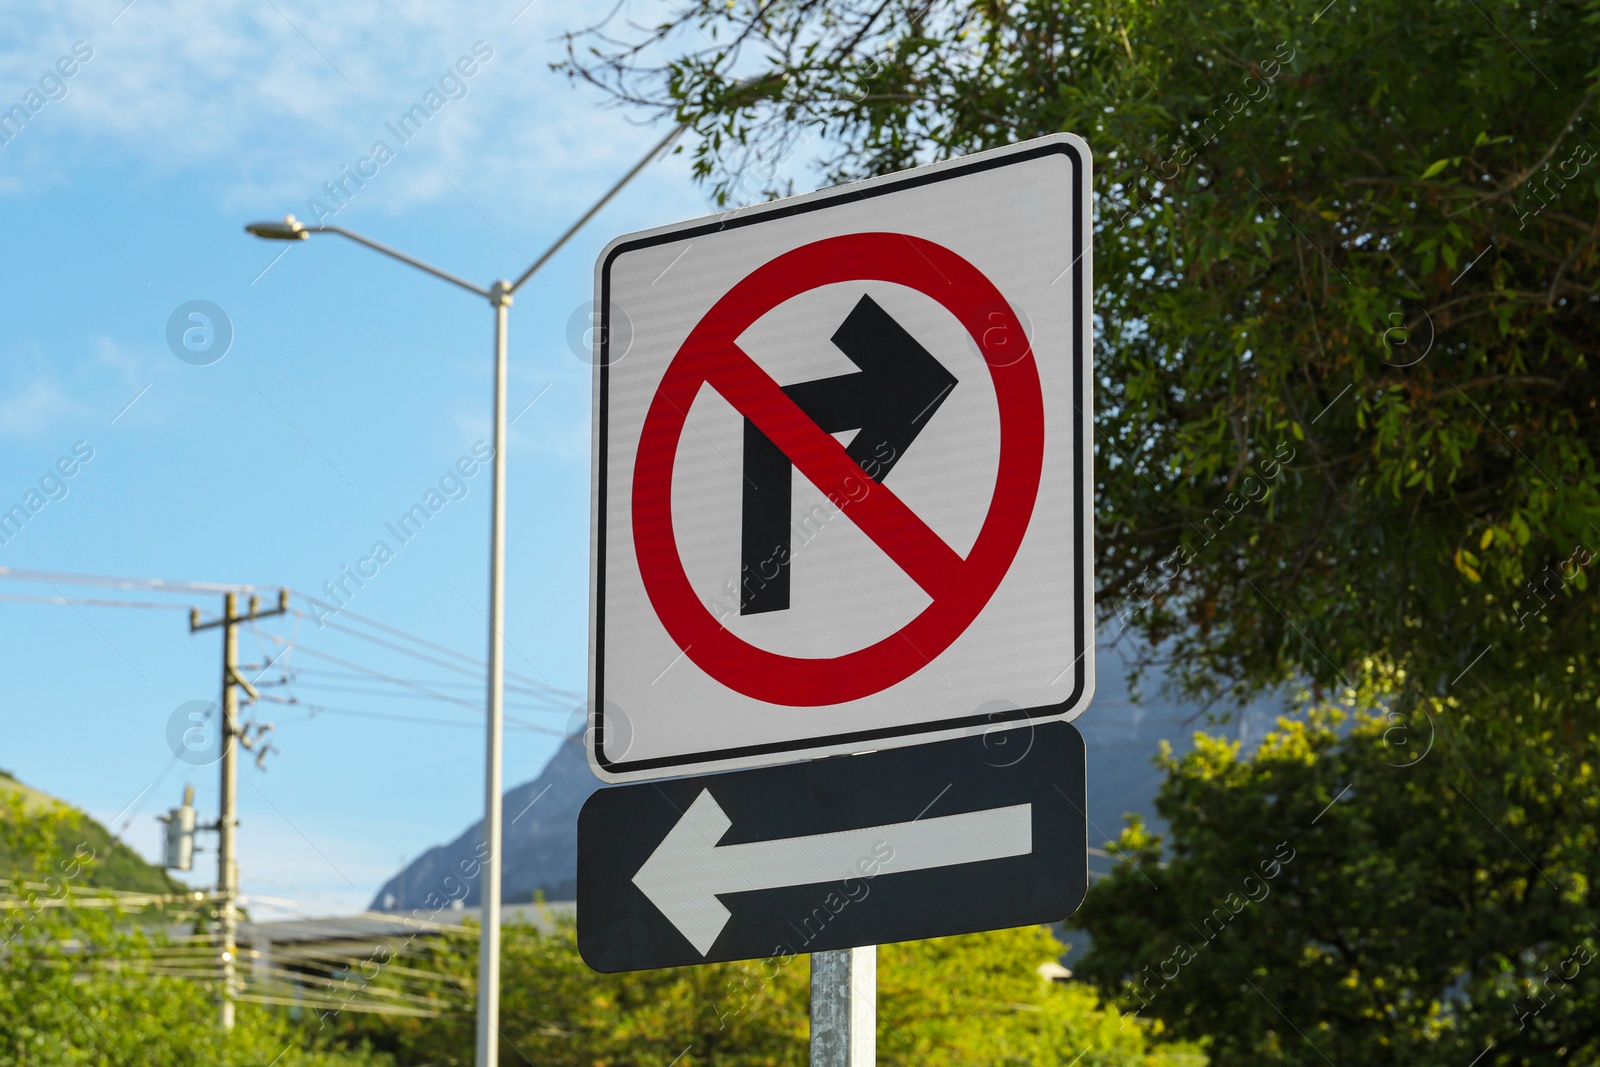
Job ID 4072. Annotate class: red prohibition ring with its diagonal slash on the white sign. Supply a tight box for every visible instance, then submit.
[630,234,1045,707]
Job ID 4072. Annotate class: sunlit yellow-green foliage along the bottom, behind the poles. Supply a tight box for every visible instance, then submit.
[0,780,1203,1067]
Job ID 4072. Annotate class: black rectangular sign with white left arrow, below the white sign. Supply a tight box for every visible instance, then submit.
[578,721,1088,971]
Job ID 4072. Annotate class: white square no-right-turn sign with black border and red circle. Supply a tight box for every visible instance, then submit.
[589,134,1094,782]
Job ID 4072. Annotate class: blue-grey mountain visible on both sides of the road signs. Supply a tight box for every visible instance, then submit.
[371,645,1282,910]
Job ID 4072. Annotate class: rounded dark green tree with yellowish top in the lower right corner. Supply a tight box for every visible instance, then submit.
[1074,678,1600,1067]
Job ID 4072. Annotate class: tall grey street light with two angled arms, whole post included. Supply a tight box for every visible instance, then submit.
[245,123,688,1067]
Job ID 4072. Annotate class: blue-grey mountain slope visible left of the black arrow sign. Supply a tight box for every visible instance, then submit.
[370,736,600,912]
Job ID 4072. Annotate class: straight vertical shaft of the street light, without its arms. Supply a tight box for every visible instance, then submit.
[475,282,510,1067]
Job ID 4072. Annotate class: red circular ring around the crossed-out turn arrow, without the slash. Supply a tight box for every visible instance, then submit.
[634,234,1045,707]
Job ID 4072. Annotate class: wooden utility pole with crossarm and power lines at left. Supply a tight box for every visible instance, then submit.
[189,589,290,1030]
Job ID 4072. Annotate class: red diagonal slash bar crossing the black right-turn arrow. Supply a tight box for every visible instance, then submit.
[706,346,965,600]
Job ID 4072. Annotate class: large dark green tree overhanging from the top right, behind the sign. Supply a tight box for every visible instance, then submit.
[566,0,1600,709]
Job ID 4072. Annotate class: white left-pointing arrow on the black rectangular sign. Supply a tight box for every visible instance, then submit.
[634,790,1034,955]
